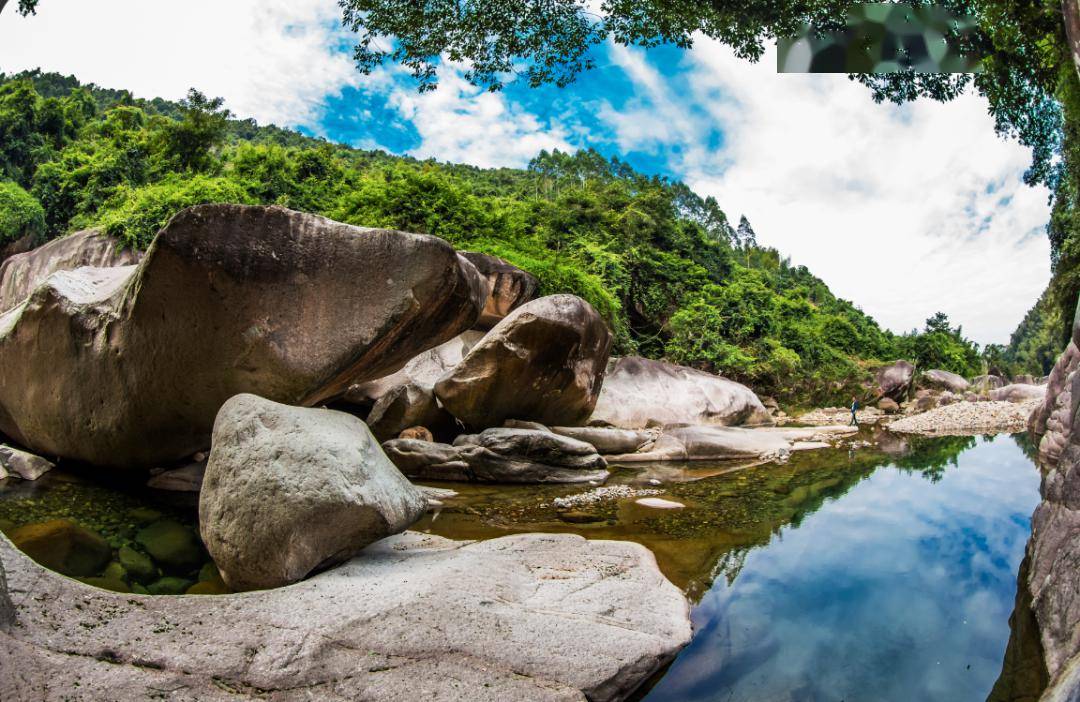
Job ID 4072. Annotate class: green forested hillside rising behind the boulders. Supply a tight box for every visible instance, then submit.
[0,72,984,404]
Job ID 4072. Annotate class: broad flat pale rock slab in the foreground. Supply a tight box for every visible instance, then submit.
[0,532,690,702]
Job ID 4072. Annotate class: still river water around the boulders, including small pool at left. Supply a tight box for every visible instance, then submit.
[0,429,1042,702]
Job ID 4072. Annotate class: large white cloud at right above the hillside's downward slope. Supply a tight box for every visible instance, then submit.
[600,41,1049,343]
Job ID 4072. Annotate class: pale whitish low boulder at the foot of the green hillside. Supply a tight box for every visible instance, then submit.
[589,356,772,429]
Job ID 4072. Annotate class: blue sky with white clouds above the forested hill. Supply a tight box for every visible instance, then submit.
[0,0,1050,343]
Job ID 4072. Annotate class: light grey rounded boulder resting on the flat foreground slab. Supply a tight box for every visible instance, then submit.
[199,394,427,591]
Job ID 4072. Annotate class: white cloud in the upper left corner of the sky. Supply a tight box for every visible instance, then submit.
[0,0,362,126]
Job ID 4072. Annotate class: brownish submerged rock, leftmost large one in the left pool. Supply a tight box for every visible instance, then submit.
[9,519,112,578]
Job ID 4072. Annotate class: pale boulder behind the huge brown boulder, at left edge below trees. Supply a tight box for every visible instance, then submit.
[0,229,143,312]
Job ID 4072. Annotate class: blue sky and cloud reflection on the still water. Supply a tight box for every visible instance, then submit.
[645,436,1039,702]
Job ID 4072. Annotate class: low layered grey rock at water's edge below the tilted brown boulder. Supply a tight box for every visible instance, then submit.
[382,428,607,483]
